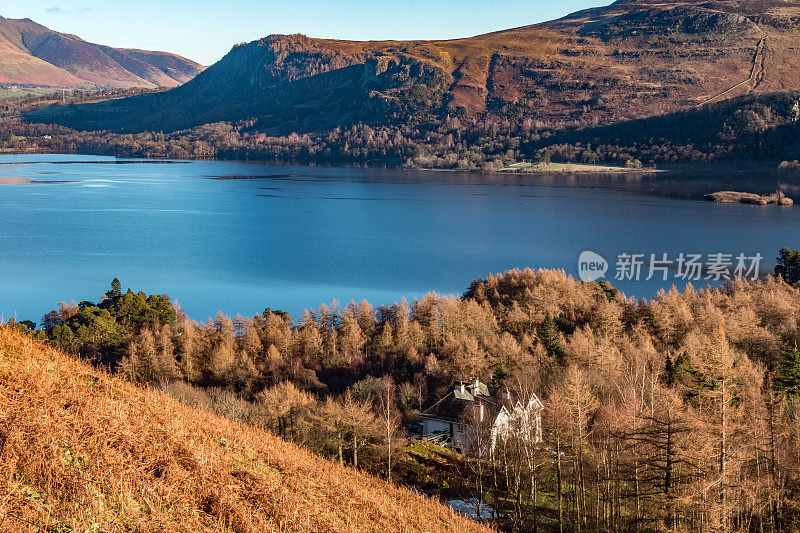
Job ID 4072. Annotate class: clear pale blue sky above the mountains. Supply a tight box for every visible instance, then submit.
[0,0,611,65]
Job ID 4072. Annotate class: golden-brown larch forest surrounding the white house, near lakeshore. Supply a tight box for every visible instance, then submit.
[7,249,800,532]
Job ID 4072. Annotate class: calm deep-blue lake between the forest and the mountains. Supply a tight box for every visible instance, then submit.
[0,155,800,322]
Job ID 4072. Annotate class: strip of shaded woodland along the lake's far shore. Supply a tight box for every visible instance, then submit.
[0,88,800,171]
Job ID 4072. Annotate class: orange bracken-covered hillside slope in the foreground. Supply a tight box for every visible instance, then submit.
[0,328,484,532]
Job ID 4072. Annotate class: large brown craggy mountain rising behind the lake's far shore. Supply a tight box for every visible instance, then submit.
[25,0,800,132]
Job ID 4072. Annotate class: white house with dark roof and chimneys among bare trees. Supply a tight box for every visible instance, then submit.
[420,379,544,450]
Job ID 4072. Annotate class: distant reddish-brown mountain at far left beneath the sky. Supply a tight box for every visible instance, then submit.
[0,17,203,88]
